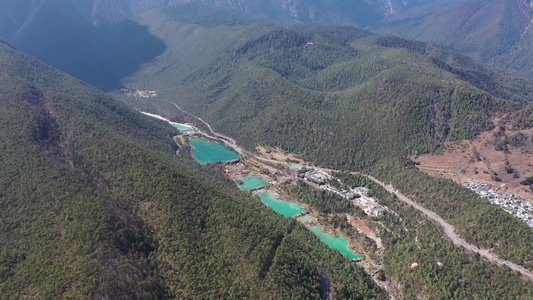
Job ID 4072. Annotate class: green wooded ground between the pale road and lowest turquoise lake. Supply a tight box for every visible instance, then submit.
[336,173,533,299]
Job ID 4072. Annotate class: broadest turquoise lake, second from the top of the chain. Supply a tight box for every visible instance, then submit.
[189,138,240,163]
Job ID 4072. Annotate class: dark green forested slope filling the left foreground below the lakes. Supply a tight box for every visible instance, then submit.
[0,43,381,299]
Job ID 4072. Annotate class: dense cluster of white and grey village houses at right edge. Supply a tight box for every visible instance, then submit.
[464,181,533,228]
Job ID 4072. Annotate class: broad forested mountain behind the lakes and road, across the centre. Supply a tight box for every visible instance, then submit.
[116,12,533,284]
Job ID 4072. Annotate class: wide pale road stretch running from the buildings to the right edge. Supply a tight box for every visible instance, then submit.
[368,176,533,280]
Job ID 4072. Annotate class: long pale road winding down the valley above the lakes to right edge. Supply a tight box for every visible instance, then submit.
[158,100,533,281]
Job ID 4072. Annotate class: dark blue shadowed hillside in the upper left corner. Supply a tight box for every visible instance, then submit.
[0,0,165,90]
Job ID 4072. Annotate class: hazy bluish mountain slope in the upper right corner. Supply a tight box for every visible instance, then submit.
[371,0,533,78]
